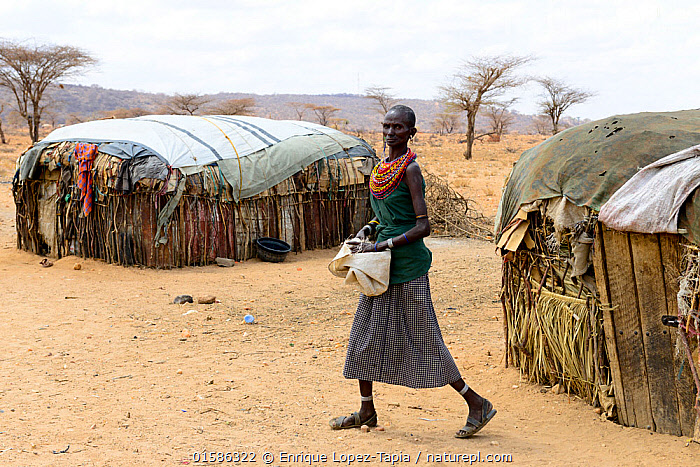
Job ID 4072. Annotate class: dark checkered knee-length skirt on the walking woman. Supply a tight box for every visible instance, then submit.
[343,274,461,388]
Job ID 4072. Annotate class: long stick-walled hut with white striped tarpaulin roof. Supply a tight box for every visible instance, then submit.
[13,115,376,268]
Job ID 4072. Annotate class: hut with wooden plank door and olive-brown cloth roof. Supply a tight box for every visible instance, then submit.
[496,110,700,440]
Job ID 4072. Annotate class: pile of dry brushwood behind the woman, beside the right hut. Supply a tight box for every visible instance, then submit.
[423,170,493,241]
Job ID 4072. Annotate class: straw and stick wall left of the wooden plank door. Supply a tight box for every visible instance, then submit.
[501,213,611,405]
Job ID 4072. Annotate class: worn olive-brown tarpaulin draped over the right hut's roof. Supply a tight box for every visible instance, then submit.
[496,110,700,241]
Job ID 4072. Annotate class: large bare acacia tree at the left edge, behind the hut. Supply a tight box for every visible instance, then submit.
[0,40,97,143]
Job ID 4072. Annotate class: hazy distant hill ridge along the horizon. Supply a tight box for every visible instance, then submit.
[0,84,584,134]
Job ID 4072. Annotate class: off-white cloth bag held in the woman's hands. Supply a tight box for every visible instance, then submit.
[328,242,391,297]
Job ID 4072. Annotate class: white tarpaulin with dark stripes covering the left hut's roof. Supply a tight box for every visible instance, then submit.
[19,115,375,200]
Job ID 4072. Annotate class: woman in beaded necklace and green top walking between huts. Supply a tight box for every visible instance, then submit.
[330,105,496,438]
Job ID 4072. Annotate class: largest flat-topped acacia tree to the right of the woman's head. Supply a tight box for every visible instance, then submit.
[440,55,533,160]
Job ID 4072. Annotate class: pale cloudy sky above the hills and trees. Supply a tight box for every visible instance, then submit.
[0,0,700,120]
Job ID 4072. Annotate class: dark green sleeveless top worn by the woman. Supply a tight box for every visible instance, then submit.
[370,180,433,284]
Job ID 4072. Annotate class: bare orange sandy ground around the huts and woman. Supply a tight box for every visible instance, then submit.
[0,129,700,466]
